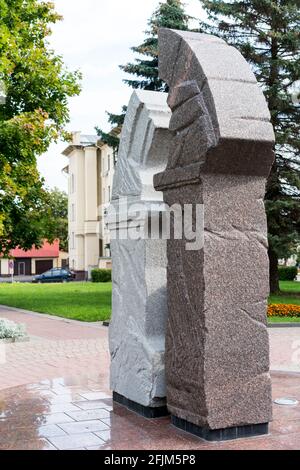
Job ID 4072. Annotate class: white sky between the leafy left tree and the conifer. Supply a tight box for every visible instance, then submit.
[39,0,202,190]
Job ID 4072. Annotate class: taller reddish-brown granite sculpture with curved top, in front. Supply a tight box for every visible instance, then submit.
[154,29,274,440]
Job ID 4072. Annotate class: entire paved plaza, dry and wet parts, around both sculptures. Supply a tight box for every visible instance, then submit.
[0,308,300,450]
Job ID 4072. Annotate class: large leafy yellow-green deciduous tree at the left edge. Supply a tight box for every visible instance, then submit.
[0,0,80,254]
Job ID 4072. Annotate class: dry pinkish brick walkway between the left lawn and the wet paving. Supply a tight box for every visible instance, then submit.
[0,307,109,390]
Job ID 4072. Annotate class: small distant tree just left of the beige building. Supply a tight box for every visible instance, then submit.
[44,188,69,252]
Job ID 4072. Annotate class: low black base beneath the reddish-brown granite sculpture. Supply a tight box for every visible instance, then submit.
[171,415,269,441]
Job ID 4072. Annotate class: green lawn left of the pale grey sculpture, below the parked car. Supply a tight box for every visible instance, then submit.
[0,282,111,322]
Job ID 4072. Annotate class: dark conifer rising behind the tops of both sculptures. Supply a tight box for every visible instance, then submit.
[96,0,190,147]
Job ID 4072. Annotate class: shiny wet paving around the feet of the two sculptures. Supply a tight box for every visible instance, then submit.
[0,372,300,450]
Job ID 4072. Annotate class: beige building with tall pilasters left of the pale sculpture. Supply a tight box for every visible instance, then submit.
[65,133,114,272]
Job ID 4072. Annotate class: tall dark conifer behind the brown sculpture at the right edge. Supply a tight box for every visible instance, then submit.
[202,0,300,293]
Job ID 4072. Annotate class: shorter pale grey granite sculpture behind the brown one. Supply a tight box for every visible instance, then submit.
[107,91,171,417]
